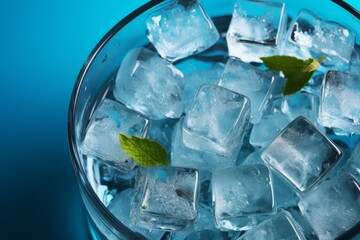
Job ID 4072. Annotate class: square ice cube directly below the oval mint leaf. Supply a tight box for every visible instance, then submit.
[131,167,199,230]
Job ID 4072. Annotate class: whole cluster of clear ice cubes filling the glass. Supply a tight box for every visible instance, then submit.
[80,0,360,240]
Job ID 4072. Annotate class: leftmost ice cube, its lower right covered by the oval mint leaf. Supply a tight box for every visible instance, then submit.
[81,99,149,171]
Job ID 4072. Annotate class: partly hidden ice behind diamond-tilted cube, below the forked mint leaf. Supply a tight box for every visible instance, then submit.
[250,92,320,147]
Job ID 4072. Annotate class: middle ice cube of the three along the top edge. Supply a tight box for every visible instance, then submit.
[226,0,287,62]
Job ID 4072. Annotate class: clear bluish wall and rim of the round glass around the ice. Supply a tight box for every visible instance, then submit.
[68,0,360,239]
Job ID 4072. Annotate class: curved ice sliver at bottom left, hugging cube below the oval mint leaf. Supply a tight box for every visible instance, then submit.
[108,188,164,239]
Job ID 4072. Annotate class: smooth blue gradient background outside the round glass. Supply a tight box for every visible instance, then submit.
[0,0,360,239]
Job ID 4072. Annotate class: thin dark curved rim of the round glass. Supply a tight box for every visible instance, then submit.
[67,0,360,239]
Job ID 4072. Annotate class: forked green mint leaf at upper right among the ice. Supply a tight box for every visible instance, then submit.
[260,56,325,95]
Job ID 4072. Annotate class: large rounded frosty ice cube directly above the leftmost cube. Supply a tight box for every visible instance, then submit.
[114,48,184,120]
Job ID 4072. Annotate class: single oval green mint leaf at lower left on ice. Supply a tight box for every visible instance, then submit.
[119,134,170,167]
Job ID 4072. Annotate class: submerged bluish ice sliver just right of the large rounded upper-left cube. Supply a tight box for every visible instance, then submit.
[183,63,224,112]
